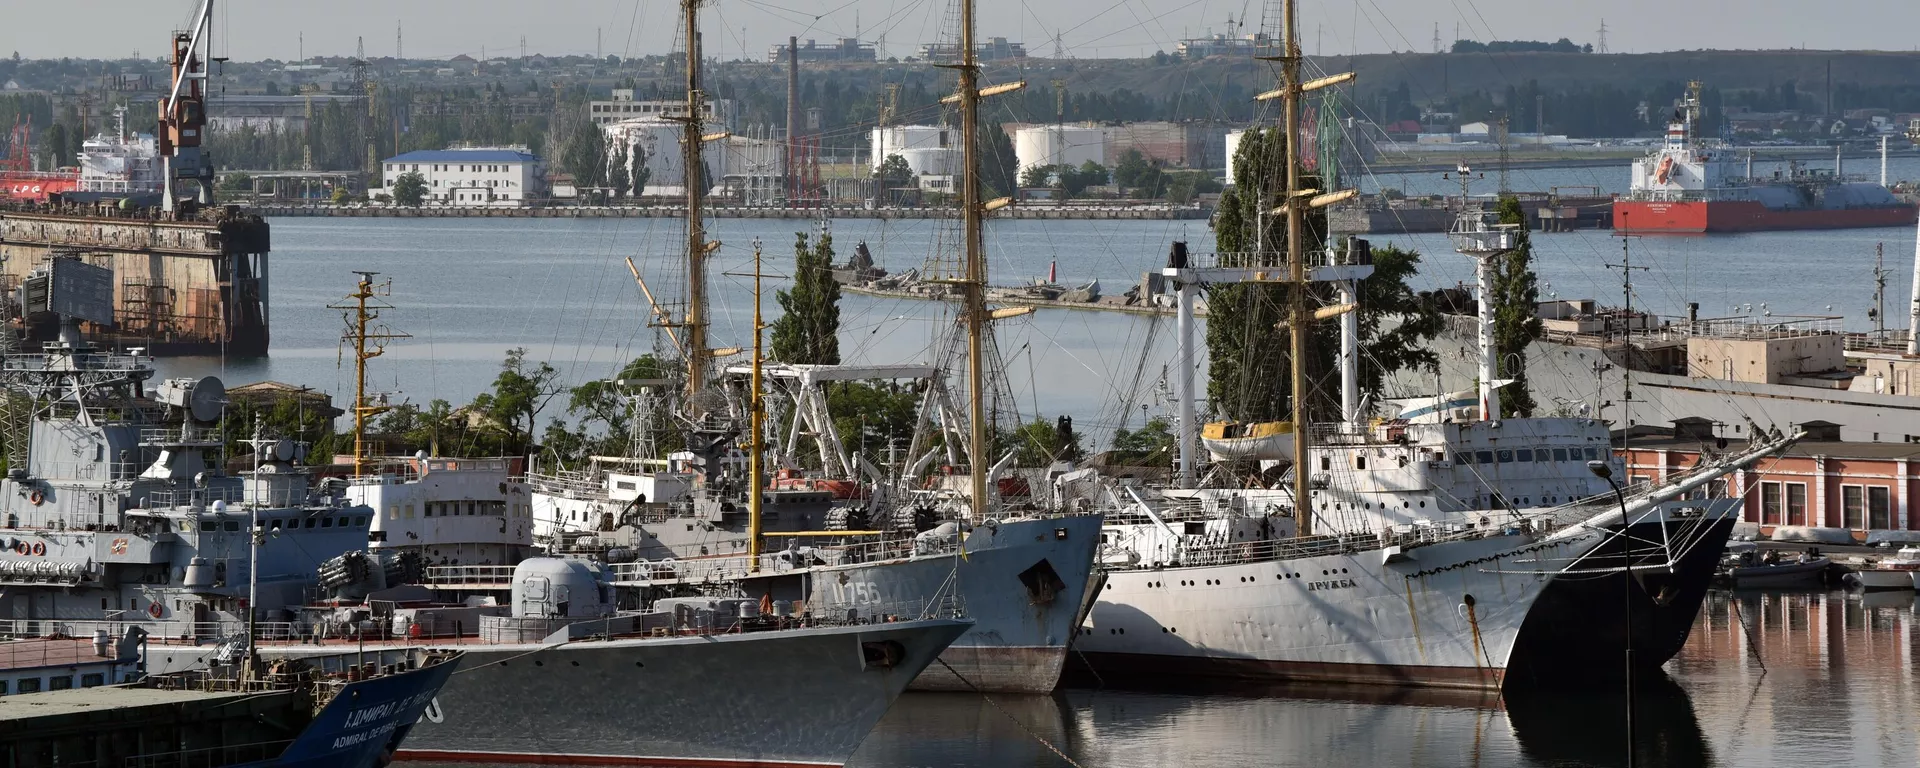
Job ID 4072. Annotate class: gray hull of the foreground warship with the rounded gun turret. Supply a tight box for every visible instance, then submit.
[385,620,966,766]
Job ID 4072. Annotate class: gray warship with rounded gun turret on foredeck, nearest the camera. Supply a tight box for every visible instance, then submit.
[150,557,970,766]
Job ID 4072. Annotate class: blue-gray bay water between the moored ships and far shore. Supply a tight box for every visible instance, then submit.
[159,202,1914,440]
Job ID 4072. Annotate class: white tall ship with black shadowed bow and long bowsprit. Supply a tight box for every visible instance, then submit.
[1060,21,1793,687]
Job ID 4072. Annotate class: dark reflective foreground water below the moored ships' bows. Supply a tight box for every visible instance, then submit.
[397,591,1920,768]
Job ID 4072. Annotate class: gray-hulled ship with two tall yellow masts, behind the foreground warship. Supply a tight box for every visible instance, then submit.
[528,2,1100,693]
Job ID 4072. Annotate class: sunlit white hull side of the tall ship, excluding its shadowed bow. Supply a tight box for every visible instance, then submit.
[1075,534,1601,689]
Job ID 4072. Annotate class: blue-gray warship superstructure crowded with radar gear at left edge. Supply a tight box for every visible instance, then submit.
[0,257,395,643]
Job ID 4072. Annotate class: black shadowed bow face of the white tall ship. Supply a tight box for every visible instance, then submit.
[1507,499,1740,685]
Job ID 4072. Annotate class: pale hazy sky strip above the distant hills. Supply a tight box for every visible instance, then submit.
[0,0,1920,60]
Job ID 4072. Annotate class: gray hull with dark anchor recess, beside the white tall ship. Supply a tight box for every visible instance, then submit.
[808,515,1102,693]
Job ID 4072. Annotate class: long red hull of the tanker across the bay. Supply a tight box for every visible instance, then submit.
[1613,200,1914,234]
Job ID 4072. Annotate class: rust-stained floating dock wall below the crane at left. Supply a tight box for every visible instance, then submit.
[0,202,273,357]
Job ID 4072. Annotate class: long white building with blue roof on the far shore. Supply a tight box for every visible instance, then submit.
[380,146,547,205]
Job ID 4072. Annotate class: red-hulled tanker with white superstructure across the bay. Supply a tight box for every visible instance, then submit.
[1613,81,1916,234]
